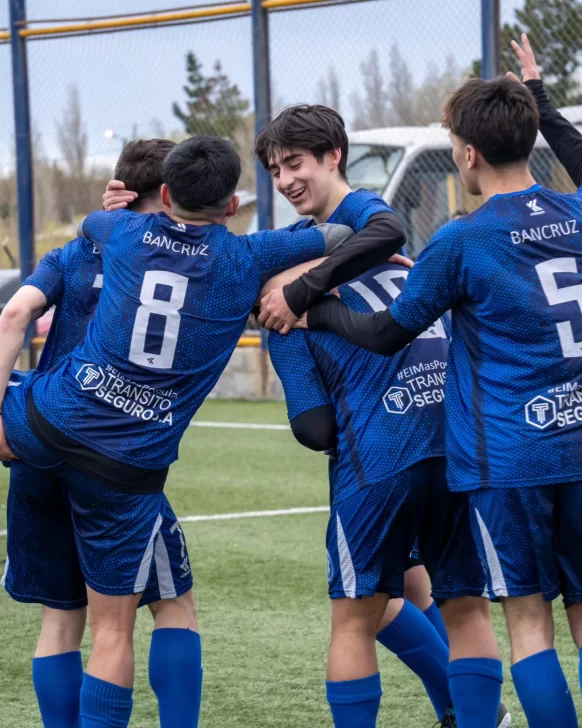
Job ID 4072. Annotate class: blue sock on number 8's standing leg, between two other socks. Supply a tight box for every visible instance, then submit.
[81,673,133,728]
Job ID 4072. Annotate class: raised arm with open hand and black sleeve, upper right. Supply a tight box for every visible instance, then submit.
[507,33,582,187]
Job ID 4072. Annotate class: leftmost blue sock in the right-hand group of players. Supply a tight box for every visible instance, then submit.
[326,672,382,728]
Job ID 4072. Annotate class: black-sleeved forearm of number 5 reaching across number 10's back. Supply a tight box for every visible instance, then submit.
[307,296,419,356]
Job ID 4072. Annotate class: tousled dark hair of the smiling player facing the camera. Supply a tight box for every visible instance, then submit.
[255,104,349,179]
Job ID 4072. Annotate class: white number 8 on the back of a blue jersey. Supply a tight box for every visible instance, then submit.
[129,270,188,369]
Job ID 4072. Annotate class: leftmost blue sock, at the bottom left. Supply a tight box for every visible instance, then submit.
[32,652,83,728]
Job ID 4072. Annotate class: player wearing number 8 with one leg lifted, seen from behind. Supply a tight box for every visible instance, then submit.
[0,137,403,728]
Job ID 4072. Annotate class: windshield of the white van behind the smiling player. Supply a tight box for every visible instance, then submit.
[347,144,404,195]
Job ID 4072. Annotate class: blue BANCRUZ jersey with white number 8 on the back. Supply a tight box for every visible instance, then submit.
[34,211,338,470]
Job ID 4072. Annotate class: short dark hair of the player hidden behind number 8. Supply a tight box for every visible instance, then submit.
[115,139,176,210]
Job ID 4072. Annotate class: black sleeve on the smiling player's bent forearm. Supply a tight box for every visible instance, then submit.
[283,212,406,316]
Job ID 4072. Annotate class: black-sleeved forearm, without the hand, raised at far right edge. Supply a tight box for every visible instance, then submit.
[525,80,582,187]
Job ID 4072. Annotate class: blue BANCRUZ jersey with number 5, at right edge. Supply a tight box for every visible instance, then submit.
[391,185,582,490]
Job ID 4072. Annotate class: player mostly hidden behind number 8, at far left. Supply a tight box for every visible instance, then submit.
[3,139,208,728]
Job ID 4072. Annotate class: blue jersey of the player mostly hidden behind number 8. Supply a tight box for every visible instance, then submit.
[23,238,103,372]
